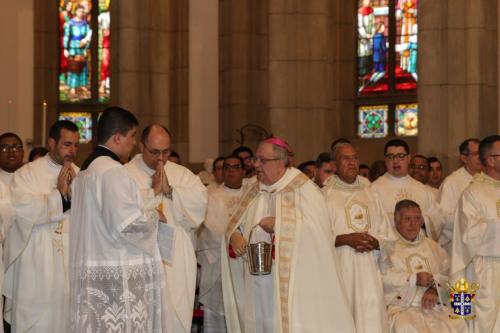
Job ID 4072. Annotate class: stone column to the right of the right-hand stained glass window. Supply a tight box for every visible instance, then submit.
[418,0,498,170]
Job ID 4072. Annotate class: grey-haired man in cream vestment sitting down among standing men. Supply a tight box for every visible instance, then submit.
[380,200,467,333]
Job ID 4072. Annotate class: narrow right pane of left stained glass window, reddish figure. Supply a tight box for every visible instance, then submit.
[97,0,111,102]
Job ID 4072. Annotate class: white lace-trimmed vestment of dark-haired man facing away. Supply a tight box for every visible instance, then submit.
[68,154,168,333]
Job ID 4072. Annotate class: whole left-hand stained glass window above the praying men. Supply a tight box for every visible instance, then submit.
[57,0,111,143]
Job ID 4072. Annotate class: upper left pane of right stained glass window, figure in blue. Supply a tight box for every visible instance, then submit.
[357,0,389,96]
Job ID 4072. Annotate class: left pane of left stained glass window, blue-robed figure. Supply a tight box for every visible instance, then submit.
[59,0,92,102]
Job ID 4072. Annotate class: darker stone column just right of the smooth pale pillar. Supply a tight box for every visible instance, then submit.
[219,0,269,154]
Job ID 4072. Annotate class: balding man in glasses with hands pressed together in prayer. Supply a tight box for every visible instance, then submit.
[125,124,207,332]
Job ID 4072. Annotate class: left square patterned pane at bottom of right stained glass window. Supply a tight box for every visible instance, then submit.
[358,105,389,139]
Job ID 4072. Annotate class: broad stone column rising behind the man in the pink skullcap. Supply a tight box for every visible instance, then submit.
[269,0,335,161]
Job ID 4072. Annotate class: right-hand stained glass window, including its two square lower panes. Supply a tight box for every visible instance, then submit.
[356,0,418,138]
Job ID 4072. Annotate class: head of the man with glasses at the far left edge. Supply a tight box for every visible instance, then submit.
[0,132,24,186]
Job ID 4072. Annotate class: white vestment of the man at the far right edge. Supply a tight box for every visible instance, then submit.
[451,173,500,333]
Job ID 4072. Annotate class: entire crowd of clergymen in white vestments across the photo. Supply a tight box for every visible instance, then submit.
[0,107,500,333]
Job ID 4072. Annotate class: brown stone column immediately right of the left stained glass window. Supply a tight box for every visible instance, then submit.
[116,0,170,127]
